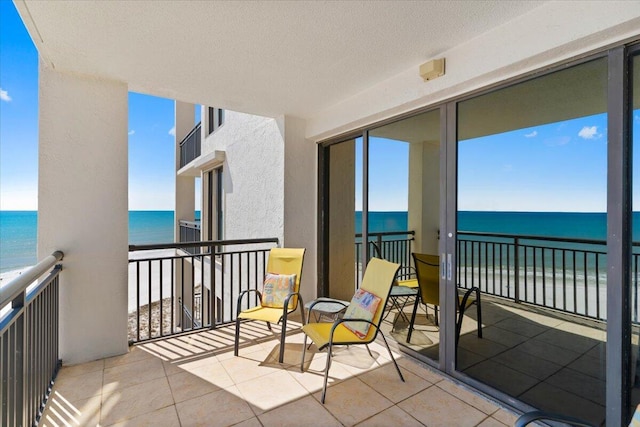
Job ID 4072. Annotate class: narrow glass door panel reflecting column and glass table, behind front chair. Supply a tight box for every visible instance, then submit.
[368,110,440,360]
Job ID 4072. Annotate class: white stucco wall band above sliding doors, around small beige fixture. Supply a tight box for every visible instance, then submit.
[306,1,640,141]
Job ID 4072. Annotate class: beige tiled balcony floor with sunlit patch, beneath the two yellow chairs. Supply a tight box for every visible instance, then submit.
[41,322,516,427]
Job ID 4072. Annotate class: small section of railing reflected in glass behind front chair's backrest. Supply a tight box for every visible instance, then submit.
[355,231,415,287]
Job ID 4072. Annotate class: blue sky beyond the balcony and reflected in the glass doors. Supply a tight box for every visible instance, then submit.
[0,0,640,212]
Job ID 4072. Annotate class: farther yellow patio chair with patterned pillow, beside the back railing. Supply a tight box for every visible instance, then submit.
[233,248,304,363]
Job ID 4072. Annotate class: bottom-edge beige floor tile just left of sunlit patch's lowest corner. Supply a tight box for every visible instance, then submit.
[176,390,254,427]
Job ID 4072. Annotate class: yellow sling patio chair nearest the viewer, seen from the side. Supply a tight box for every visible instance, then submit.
[300,258,404,403]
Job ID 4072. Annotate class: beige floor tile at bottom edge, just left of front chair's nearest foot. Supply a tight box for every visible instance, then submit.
[258,396,342,427]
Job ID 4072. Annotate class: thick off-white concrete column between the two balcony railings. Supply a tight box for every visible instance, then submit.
[38,62,129,364]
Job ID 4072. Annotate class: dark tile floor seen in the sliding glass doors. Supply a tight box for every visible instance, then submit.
[387,295,608,425]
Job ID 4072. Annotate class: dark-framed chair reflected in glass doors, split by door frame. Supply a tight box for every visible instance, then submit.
[407,252,482,348]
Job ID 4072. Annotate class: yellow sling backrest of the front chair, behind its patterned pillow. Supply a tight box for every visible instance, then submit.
[360,258,400,341]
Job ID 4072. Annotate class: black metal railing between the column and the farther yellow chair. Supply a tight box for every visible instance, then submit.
[129,238,278,342]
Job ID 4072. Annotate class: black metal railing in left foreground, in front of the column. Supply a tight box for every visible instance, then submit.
[0,251,63,426]
